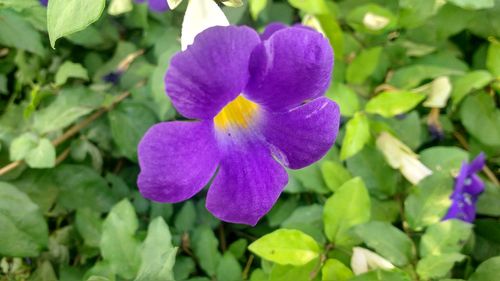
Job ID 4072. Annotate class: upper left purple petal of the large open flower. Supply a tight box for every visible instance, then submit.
[165,25,260,119]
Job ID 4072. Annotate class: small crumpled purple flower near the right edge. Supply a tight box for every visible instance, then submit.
[443,153,485,222]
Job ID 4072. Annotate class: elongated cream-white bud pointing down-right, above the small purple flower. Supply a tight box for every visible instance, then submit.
[377,132,432,184]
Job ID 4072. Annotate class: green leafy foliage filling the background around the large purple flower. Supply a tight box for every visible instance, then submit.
[0,0,500,281]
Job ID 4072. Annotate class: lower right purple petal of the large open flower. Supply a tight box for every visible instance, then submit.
[261,98,340,169]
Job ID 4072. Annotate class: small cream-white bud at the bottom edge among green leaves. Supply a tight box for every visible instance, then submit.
[351,247,394,275]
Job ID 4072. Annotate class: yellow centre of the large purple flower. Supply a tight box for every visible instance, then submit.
[214,95,258,130]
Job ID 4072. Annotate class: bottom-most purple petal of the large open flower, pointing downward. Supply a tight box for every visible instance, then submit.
[206,141,288,225]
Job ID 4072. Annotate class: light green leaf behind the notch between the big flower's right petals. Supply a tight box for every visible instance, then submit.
[326,82,360,116]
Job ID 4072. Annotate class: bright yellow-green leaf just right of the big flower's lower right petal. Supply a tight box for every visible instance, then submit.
[340,112,371,160]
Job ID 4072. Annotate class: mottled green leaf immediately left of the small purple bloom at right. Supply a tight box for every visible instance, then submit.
[405,173,453,231]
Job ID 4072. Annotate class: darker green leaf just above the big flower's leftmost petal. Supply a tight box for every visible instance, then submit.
[108,101,156,161]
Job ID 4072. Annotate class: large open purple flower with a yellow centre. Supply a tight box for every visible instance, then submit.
[138,26,340,225]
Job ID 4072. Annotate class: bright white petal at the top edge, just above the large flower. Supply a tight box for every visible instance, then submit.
[181,0,229,50]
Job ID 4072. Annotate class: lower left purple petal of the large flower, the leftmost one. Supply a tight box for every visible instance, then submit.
[137,121,219,203]
